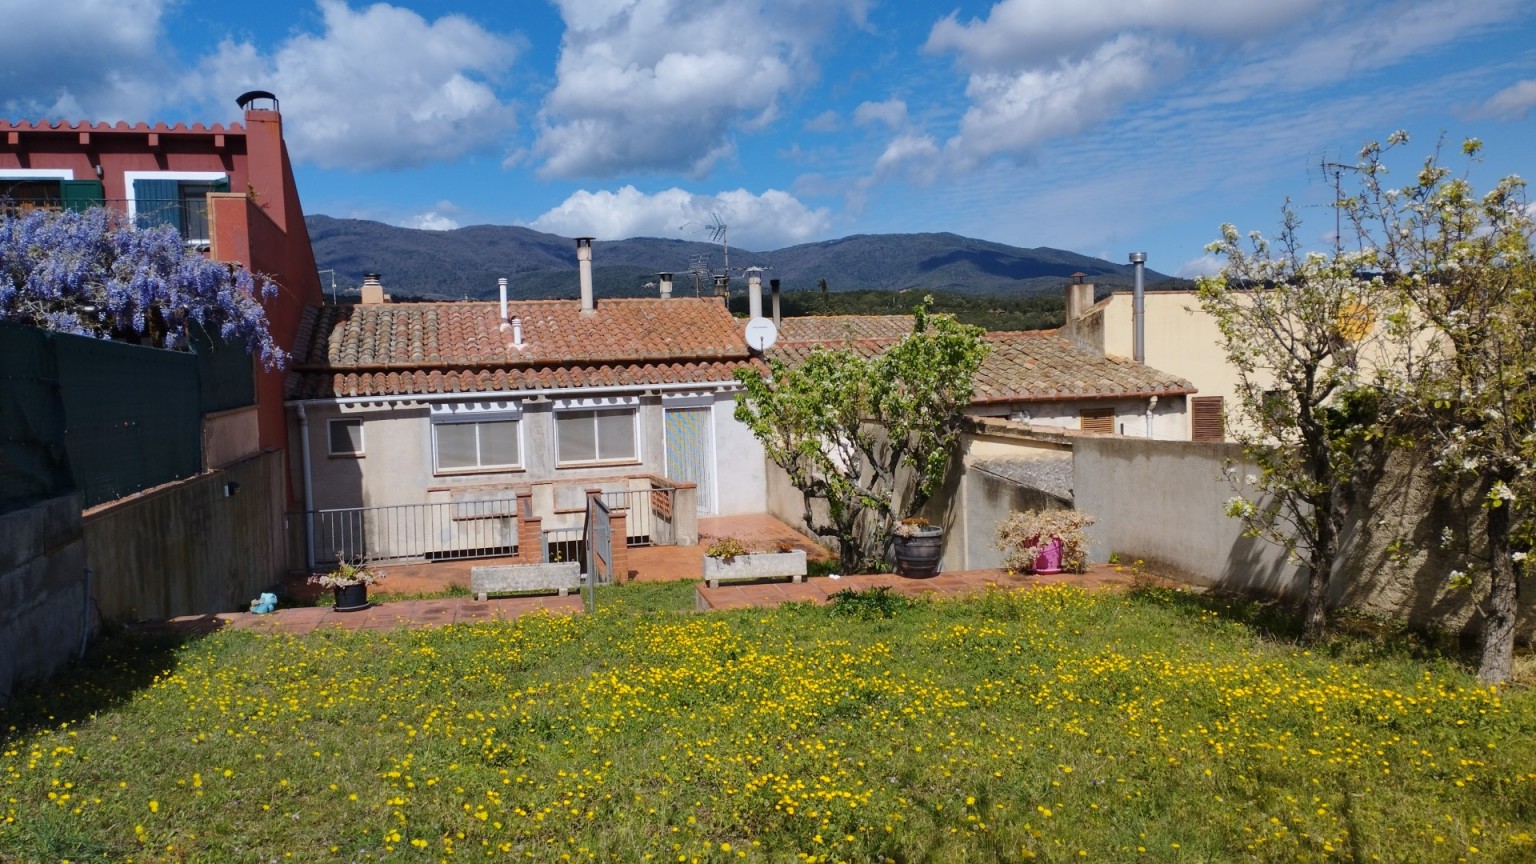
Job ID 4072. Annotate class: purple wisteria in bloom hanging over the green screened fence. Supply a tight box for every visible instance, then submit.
[0,208,287,369]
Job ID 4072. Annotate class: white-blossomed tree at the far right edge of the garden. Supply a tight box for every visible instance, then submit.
[1344,132,1536,683]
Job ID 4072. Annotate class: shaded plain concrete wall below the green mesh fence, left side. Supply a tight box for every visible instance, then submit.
[84,450,287,618]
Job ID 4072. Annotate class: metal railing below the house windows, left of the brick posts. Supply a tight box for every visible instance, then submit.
[304,498,518,567]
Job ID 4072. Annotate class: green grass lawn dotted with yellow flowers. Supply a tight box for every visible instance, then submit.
[0,587,1536,862]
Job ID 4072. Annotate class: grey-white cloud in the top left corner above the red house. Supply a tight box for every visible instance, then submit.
[0,0,174,121]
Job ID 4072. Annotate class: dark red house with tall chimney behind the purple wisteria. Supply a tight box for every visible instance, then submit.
[0,91,323,491]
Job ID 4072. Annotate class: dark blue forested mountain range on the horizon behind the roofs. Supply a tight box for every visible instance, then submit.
[304,215,1169,300]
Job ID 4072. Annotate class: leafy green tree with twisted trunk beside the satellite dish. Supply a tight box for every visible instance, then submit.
[736,300,988,572]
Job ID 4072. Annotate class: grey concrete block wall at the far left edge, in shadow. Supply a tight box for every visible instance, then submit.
[0,495,92,704]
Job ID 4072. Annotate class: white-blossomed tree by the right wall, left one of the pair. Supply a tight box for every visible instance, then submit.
[1200,203,1390,641]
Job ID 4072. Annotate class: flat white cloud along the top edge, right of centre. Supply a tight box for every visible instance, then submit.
[926,0,1320,71]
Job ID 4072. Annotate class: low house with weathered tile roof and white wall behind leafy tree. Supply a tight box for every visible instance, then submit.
[768,315,1195,440]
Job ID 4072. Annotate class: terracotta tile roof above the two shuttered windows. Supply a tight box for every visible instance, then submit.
[287,298,753,398]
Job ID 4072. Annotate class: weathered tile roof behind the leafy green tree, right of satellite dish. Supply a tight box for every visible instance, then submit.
[768,315,1195,404]
